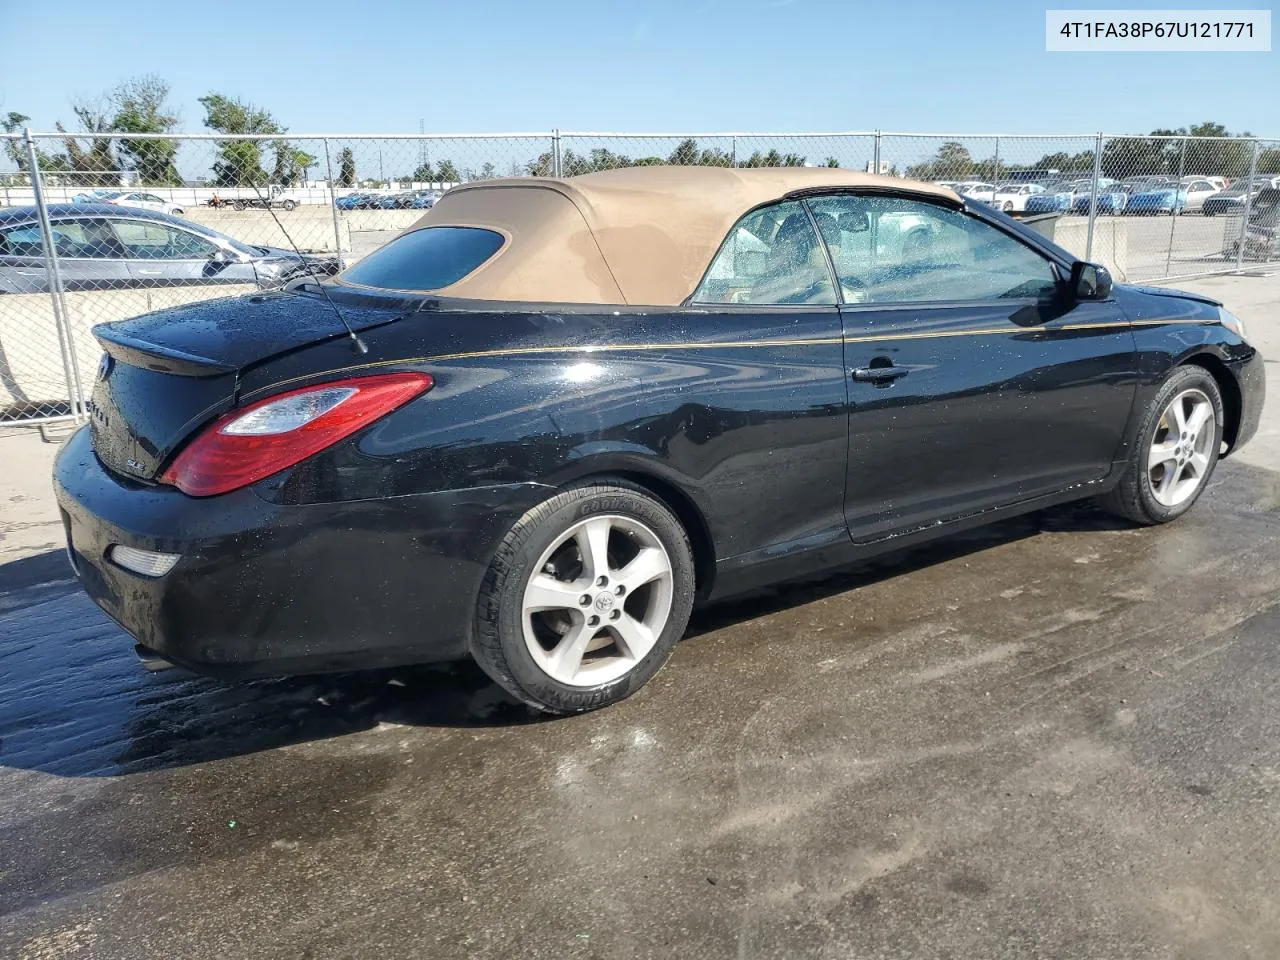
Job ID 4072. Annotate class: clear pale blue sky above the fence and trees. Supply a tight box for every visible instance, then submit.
[0,0,1280,137]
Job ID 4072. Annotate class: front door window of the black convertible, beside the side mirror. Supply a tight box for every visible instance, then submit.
[809,195,1057,303]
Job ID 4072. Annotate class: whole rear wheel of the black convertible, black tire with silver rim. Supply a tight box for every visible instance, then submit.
[471,480,694,714]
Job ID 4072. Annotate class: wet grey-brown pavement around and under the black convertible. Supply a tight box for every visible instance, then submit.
[0,276,1280,960]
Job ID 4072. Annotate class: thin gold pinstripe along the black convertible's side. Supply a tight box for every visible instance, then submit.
[246,320,1217,397]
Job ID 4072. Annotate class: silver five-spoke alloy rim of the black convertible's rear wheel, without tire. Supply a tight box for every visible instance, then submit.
[521,515,675,686]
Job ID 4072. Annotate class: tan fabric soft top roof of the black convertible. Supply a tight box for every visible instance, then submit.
[399,166,960,306]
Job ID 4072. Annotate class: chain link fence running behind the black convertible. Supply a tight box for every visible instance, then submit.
[0,131,1280,424]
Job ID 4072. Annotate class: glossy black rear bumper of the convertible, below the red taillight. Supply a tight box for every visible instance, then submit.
[54,430,545,676]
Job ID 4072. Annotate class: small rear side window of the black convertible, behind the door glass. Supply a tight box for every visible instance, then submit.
[692,201,836,306]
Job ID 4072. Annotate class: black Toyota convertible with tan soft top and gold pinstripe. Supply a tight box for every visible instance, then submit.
[55,168,1263,713]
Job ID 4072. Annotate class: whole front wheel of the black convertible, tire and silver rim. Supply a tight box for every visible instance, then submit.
[1098,366,1225,526]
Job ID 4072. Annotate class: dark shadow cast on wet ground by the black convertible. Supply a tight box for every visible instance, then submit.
[0,504,1187,777]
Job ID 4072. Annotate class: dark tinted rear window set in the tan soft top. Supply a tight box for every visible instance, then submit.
[342,227,502,291]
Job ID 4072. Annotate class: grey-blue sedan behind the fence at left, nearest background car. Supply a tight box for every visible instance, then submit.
[0,204,343,294]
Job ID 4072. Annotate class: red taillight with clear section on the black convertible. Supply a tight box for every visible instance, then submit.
[160,374,434,497]
